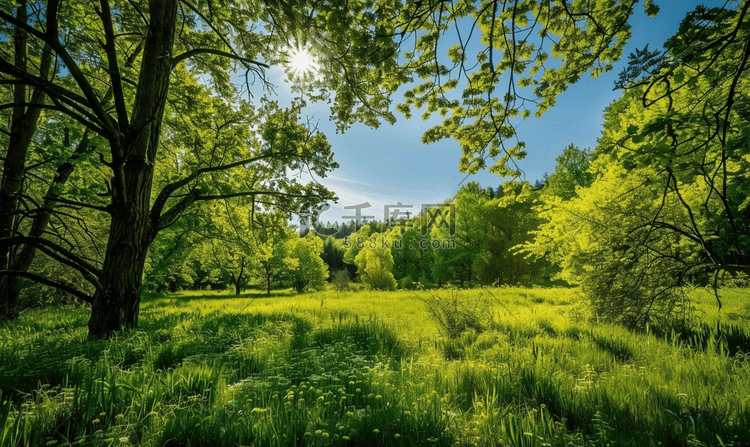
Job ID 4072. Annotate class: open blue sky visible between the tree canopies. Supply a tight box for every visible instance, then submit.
[268,1,724,226]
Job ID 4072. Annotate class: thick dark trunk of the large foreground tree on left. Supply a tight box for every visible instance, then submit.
[89,0,177,338]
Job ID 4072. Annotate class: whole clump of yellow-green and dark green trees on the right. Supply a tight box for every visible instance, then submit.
[531,2,750,326]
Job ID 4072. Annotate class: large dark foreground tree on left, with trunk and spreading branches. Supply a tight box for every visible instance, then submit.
[0,0,400,336]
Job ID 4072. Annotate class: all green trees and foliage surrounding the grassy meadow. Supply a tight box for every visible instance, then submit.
[0,0,750,337]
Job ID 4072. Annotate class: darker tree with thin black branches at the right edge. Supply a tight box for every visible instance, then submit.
[605,1,750,292]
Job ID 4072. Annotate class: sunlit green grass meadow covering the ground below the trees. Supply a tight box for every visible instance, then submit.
[0,288,750,447]
